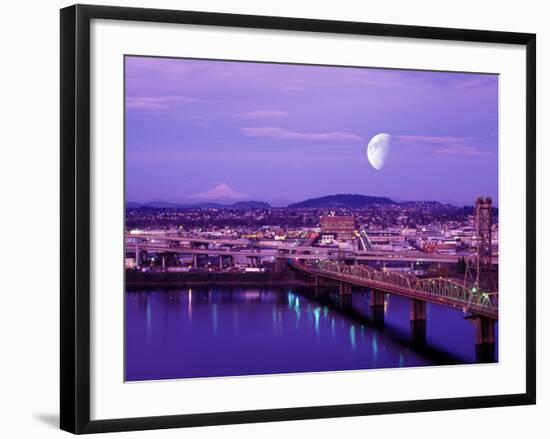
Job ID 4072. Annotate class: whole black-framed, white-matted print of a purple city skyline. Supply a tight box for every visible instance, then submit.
[61,5,536,433]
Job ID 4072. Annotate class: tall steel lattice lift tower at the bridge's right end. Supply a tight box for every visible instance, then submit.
[464,197,495,293]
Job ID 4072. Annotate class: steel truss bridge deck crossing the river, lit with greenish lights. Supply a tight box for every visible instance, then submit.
[289,260,498,320]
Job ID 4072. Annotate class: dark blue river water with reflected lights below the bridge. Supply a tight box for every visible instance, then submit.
[125,287,500,381]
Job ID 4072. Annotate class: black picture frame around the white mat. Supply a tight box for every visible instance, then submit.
[60,5,536,434]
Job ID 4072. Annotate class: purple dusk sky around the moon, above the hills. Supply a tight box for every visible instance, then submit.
[125,57,498,204]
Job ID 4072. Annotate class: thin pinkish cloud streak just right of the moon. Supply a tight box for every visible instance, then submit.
[394,136,492,156]
